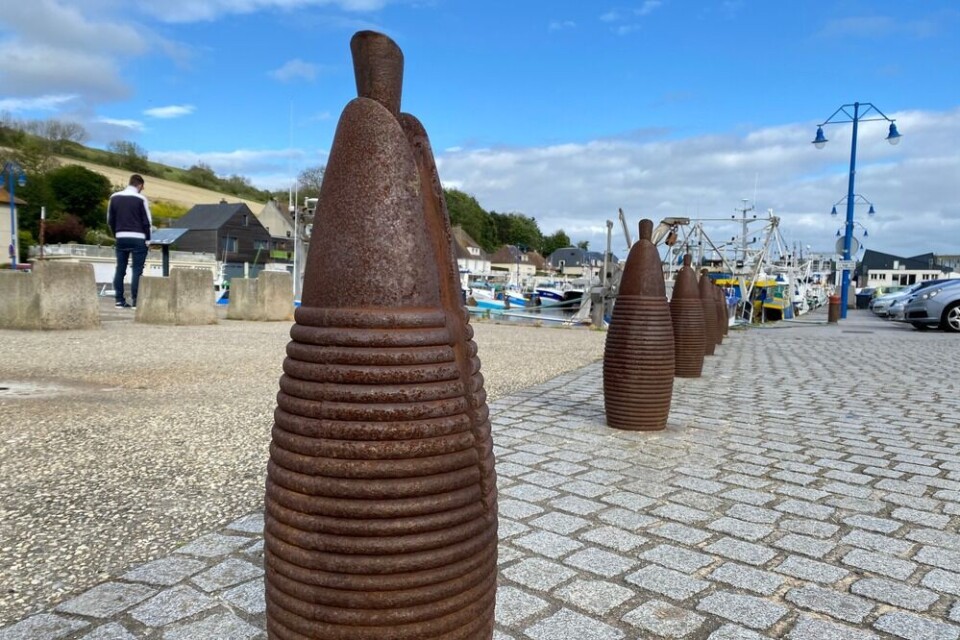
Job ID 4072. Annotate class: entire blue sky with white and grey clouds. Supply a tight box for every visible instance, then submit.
[0,0,960,257]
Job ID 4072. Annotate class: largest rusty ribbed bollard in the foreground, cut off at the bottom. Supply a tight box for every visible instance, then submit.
[264,32,497,640]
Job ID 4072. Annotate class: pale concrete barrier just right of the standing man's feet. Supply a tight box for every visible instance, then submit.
[134,269,217,325]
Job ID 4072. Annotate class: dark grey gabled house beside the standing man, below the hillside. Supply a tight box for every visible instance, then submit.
[176,200,274,277]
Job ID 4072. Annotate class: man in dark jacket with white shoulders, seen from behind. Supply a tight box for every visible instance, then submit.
[107,173,153,309]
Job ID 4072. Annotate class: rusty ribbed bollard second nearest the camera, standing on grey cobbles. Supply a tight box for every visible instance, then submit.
[603,220,675,431]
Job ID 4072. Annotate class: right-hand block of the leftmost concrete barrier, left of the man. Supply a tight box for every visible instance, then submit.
[32,262,100,329]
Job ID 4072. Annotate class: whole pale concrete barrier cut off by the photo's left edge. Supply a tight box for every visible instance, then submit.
[0,262,100,330]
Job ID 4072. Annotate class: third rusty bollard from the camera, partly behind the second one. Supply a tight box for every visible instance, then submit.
[670,253,707,378]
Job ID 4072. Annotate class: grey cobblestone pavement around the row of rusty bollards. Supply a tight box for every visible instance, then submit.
[0,312,960,640]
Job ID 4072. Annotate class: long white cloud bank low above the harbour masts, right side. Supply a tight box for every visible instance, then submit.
[438,109,960,255]
